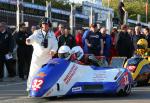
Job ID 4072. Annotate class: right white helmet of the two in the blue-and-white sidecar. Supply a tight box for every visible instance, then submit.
[71,46,84,60]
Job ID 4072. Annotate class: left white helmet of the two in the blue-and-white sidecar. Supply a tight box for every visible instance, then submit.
[58,45,70,60]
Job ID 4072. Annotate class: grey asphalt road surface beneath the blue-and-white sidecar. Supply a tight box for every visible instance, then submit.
[0,77,150,103]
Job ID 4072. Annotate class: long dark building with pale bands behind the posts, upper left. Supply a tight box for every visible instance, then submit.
[0,0,88,26]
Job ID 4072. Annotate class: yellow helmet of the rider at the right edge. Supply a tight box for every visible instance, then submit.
[137,39,148,49]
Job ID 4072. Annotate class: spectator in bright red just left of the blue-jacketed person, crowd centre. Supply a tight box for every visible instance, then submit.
[75,28,83,48]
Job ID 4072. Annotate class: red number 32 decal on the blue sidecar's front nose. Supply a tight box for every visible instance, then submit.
[32,78,44,91]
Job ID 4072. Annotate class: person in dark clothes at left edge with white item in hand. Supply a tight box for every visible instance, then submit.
[0,22,15,81]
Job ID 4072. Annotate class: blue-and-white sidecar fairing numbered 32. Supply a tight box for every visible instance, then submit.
[30,58,132,97]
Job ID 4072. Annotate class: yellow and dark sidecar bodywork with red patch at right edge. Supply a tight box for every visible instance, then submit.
[124,56,150,85]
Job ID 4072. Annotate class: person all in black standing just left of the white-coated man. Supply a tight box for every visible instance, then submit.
[15,23,33,80]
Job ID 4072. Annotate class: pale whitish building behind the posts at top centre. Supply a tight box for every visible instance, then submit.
[82,0,114,26]
